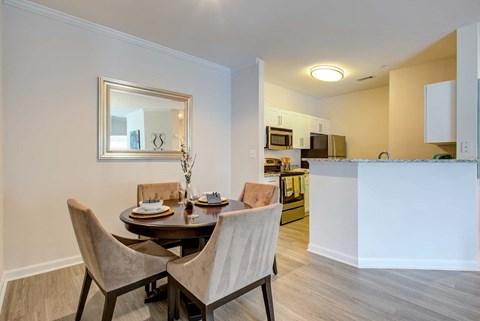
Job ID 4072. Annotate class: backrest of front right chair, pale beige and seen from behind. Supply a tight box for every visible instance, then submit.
[185,203,282,304]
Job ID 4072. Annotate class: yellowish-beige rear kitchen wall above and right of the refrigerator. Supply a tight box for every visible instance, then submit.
[318,87,388,159]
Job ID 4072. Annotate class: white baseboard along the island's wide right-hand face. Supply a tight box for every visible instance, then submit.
[358,258,479,271]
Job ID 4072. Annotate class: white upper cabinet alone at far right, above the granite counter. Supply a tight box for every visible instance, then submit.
[424,80,457,144]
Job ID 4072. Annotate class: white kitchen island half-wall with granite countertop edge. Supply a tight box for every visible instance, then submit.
[304,159,479,270]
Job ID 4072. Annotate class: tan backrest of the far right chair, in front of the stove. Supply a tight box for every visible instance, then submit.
[239,182,280,207]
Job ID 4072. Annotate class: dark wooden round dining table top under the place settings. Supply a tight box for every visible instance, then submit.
[120,200,251,239]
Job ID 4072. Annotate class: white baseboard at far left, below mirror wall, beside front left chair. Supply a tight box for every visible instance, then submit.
[4,255,83,281]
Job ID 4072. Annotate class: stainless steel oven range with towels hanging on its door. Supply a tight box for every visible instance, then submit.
[264,158,305,225]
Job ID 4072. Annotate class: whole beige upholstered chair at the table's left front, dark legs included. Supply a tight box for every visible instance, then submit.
[67,199,177,321]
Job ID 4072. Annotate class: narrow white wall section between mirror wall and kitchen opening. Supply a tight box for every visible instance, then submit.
[231,59,265,197]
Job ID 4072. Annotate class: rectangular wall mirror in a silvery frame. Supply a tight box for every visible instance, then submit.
[98,77,192,159]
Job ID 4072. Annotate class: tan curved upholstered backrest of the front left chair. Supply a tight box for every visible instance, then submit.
[67,199,165,291]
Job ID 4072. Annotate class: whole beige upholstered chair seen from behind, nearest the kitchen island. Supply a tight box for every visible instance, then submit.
[167,204,282,321]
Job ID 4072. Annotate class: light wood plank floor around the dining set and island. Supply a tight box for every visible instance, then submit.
[0,218,480,321]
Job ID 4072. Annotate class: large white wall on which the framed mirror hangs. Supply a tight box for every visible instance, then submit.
[1,5,231,269]
